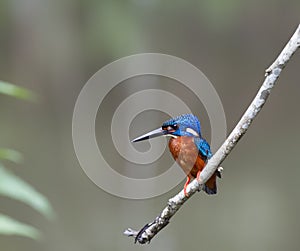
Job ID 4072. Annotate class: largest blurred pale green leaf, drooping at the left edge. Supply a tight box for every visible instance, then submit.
[0,164,54,219]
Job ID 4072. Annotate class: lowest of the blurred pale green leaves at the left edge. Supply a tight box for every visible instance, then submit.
[0,214,41,240]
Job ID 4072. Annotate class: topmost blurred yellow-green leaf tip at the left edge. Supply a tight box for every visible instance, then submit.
[0,81,37,101]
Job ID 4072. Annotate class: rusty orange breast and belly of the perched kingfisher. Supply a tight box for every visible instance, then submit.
[169,137,205,178]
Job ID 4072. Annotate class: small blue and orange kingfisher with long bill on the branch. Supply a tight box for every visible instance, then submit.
[131,114,221,196]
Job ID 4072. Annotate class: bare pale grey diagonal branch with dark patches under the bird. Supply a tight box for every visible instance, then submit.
[124,25,300,244]
